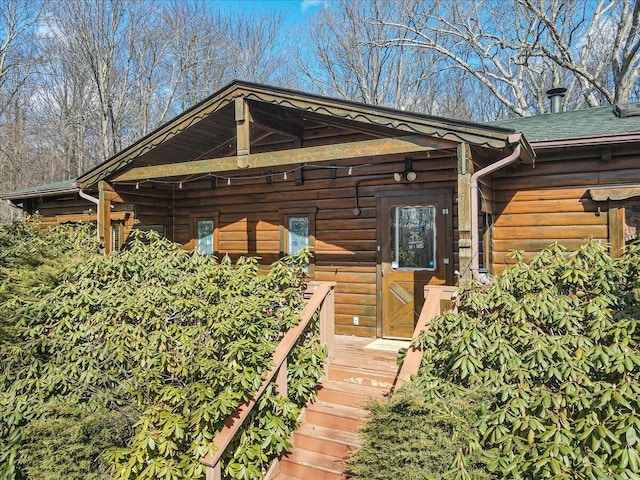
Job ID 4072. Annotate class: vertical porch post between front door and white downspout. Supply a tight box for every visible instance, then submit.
[457,143,473,281]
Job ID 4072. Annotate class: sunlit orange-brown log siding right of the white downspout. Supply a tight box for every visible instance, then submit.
[491,145,640,272]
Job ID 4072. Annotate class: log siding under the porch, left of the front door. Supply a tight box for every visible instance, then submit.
[160,152,457,336]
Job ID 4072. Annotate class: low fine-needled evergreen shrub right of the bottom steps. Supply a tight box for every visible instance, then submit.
[348,384,490,480]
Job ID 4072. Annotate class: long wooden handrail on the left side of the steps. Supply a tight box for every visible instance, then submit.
[200,282,335,480]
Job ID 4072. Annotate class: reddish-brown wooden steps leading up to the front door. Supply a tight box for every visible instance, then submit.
[272,336,398,480]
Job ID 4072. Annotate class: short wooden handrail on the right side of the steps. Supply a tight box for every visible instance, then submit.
[394,285,458,390]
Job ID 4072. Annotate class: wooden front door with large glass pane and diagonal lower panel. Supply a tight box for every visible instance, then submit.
[377,193,453,338]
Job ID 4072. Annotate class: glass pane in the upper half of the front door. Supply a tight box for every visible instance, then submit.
[391,205,436,270]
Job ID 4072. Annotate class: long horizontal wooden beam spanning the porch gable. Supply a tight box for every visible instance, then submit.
[112,135,457,182]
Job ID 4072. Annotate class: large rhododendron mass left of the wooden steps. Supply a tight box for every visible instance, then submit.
[0,226,324,479]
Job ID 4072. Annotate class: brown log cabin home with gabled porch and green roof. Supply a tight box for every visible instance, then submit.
[2,81,640,338]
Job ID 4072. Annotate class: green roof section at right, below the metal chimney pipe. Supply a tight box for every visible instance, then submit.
[486,105,640,142]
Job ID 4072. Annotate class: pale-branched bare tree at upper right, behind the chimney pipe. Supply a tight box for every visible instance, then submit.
[381,0,640,118]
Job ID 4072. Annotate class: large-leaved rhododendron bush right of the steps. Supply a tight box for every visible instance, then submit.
[408,242,640,479]
